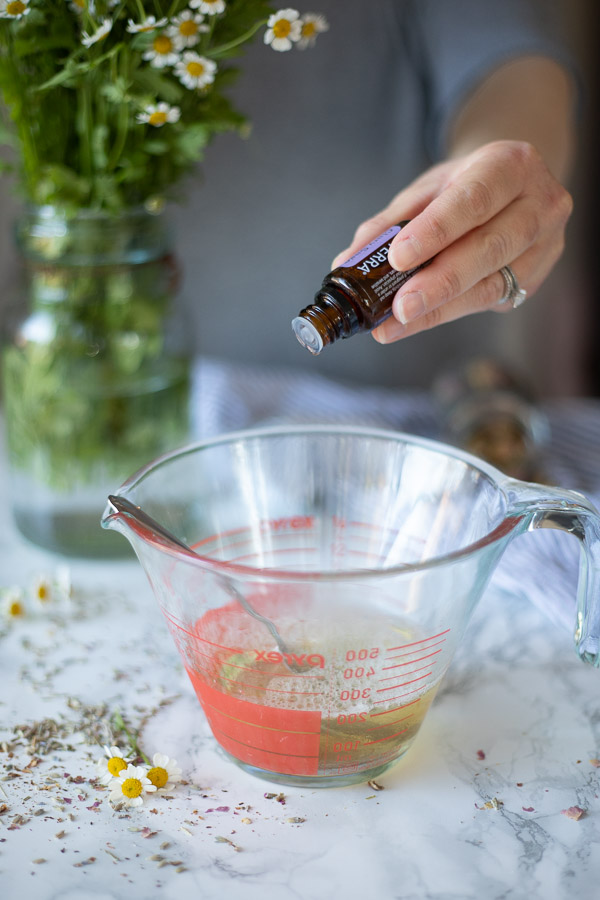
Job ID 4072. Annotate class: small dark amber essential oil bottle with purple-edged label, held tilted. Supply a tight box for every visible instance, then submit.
[292,222,431,356]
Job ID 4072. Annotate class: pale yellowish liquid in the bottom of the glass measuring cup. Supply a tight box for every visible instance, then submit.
[173,604,450,786]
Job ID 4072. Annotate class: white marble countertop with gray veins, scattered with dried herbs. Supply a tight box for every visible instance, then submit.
[0,370,600,900]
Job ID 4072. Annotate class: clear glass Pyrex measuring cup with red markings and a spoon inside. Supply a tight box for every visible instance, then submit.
[102,426,600,787]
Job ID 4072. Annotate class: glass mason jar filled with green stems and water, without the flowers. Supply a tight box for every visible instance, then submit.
[2,207,190,558]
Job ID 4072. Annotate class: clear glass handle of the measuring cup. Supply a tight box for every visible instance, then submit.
[508,481,600,666]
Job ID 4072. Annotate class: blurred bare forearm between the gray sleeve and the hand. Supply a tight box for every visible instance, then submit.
[449,56,575,183]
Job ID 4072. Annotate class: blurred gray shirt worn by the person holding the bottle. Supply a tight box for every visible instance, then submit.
[174,0,576,387]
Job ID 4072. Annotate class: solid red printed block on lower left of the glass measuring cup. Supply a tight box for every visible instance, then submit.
[186,669,321,775]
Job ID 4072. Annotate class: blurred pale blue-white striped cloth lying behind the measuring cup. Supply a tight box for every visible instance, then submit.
[192,358,600,631]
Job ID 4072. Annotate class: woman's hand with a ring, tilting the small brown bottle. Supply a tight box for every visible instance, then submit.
[334,140,572,344]
